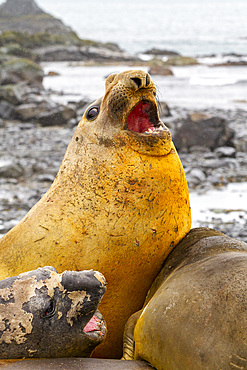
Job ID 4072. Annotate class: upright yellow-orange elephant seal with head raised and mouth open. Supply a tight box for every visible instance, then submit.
[0,70,191,358]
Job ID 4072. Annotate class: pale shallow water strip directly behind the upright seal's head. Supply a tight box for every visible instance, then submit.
[42,62,247,109]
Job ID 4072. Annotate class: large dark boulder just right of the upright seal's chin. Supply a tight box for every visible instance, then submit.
[173,117,234,150]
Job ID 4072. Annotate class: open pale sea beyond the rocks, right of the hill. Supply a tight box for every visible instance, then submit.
[32,0,247,55]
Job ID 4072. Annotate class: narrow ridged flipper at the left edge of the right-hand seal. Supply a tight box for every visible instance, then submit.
[122,310,143,360]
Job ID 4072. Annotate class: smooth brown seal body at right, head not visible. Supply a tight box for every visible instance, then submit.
[124,228,247,370]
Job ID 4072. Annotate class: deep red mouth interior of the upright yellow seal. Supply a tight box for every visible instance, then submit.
[127,100,155,133]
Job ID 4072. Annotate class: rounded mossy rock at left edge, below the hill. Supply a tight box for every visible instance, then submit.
[0,58,44,85]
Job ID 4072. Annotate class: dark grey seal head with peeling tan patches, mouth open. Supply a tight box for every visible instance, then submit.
[0,267,106,359]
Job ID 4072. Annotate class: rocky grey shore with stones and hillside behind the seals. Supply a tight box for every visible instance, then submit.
[0,0,247,241]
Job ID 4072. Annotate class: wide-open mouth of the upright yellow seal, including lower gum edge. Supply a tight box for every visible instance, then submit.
[125,100,167,134]
